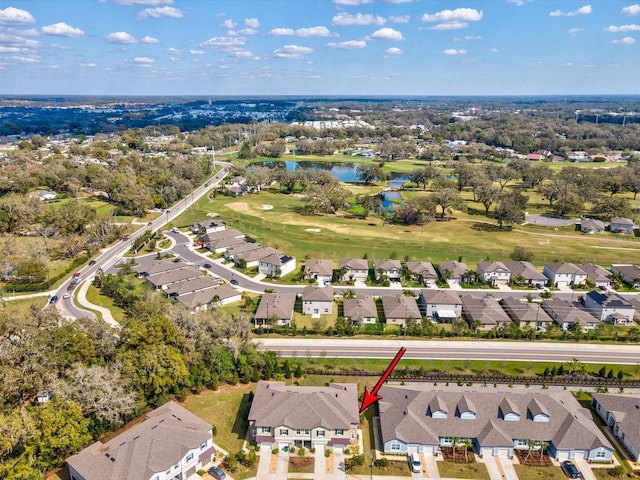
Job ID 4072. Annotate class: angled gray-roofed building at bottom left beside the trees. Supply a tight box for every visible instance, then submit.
[67,402,215,480]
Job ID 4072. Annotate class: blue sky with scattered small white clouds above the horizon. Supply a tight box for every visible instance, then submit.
[0,0,640,96]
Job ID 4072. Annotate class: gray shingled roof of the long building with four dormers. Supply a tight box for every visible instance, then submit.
[379,385,613,449]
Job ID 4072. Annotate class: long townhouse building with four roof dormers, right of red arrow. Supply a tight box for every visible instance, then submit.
[378,385,614,462]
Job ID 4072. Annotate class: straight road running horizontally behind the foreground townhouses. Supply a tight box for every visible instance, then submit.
[257,337,640,365]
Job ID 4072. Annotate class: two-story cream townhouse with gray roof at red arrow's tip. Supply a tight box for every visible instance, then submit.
[248,381,360,451]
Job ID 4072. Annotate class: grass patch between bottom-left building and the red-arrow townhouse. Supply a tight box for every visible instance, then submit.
[182,384,256,454]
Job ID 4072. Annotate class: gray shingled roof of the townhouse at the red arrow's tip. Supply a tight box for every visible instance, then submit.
[248,381,360,430]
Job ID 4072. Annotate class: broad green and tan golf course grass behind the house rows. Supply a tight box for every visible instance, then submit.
[175,186,640,266]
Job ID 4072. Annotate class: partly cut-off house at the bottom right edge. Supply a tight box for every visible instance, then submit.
[591,393,640,463]
